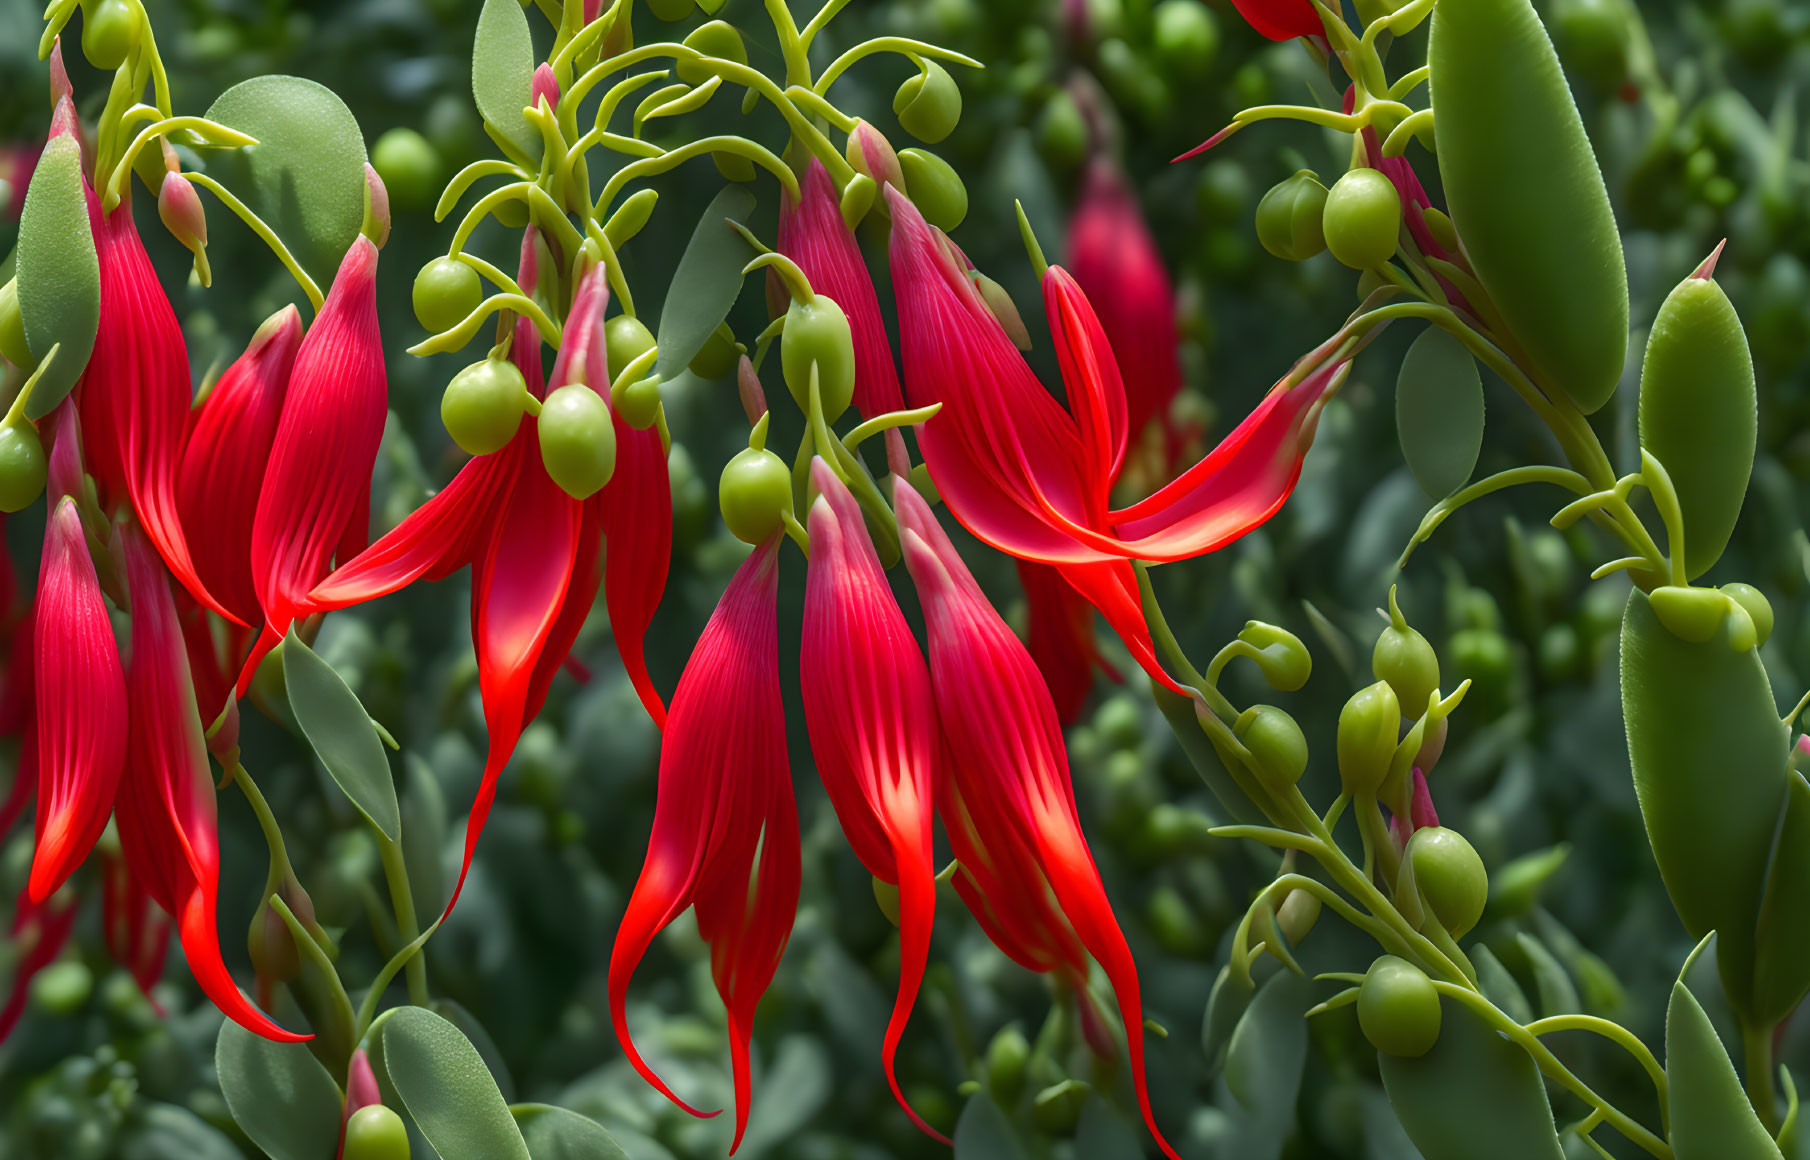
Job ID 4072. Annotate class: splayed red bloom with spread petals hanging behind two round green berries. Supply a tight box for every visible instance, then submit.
[306,238,672,912]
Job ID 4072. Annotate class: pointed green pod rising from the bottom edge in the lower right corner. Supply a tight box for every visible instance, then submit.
[1665,977,1783,1160]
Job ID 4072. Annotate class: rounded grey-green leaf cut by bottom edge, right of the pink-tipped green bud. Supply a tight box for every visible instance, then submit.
[384,1006,530,1160]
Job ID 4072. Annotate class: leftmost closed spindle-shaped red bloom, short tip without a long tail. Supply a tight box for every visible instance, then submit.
[27,496,127,903]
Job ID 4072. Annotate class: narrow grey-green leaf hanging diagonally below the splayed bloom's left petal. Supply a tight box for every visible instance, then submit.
[282,628,402,841]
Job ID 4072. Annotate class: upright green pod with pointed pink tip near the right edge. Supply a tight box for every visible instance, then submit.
[1640,262,1759,579]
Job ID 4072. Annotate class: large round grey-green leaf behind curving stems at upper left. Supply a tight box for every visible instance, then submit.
[203,76,364,288]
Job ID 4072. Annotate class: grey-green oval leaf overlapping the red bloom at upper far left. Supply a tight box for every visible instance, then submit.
[16,134,101,420]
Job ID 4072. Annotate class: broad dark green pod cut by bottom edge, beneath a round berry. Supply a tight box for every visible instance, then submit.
[1376,999,1566,1160]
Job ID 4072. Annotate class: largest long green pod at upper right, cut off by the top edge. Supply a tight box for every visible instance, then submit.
[1426,0,1627,413]
